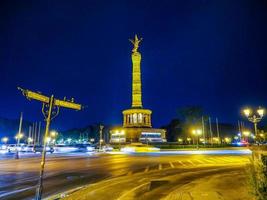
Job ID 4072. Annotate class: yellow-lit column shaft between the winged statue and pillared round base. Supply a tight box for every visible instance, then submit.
[132,52,143,108]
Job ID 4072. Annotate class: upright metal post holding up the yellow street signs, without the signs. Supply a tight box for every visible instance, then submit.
[35,95,54,200]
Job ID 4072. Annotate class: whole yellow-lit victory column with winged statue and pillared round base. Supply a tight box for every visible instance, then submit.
[110,35,165,143]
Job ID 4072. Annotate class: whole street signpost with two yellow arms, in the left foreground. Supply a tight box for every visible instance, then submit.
[18,87,82,200]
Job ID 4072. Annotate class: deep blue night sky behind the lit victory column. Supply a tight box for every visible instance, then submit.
[0,0,267,129]
